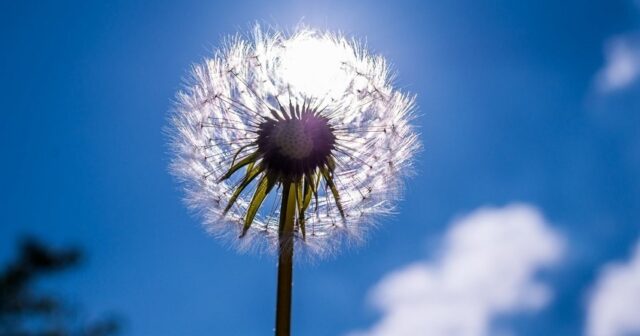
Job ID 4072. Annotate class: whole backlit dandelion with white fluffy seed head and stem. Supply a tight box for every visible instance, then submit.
[171,28,419,335]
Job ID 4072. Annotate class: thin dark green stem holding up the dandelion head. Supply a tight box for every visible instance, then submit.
[276,182,296,336]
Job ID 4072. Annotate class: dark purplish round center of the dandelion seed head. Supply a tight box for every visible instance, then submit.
[258,110,336,180]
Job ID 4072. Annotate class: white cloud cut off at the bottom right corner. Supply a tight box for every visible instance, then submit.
[587,243,640,336]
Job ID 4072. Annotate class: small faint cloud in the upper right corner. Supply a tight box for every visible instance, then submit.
[598,37,640,93]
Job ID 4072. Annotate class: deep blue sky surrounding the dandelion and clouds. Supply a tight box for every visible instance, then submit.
[0,0,640,335]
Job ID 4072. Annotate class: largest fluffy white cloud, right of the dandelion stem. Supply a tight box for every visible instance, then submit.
[353,205,564,336]
